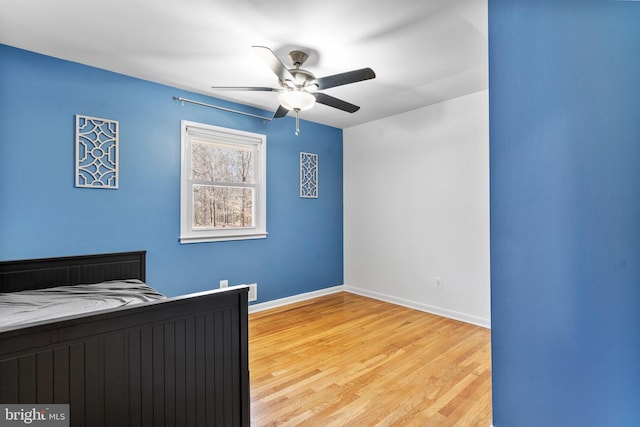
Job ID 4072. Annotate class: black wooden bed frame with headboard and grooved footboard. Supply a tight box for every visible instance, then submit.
[0,251,250,427]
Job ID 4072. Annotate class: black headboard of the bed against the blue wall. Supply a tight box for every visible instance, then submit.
[0,251,147,292]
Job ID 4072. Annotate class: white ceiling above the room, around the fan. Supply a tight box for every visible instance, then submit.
[0,0,488,128]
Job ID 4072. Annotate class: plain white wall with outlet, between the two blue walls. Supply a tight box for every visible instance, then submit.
[344,91,490,327]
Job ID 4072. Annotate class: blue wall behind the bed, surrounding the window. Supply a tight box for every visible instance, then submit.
[0,45,343,302]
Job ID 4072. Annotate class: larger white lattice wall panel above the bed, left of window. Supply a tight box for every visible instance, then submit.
[76,114,119,188]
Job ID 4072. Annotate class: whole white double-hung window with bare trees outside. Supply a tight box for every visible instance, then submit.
[180,121,267,243]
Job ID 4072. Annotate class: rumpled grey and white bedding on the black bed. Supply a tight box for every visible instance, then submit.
[0,279,165,328]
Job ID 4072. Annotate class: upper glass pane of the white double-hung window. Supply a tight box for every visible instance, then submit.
[191,138,254,184]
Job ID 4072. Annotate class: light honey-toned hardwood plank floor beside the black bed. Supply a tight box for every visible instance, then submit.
[249,292,491,427]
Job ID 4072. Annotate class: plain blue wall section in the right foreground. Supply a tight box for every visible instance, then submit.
[489,0,640,427]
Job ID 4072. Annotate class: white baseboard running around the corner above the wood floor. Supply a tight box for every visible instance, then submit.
[249,285,491,329]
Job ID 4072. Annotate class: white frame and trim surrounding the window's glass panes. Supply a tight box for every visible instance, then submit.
[180,120,267,243]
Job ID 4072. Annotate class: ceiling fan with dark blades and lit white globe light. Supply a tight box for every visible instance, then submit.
[212,46,376,135]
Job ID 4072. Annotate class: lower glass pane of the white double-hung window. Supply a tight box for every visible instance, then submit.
[193,185,255,229]
